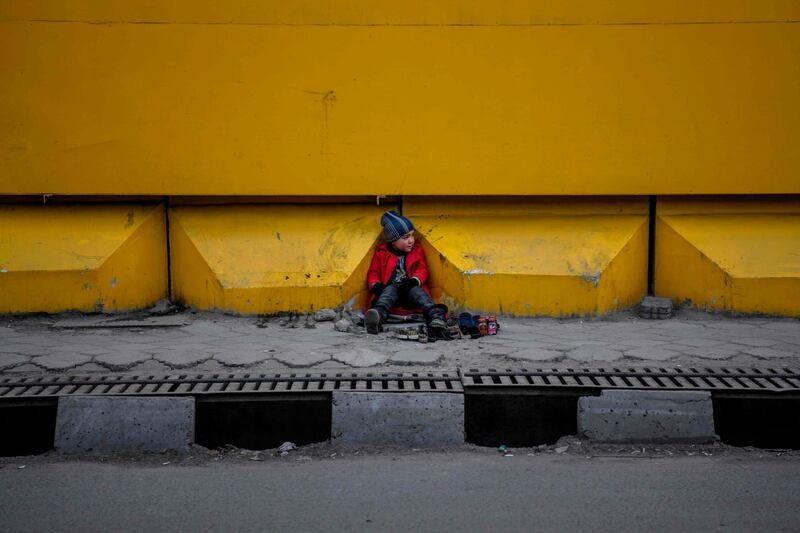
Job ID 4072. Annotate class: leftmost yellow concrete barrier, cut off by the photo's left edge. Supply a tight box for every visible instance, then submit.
[0,204,168,313]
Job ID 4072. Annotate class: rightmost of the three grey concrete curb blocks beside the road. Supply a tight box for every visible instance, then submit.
[578,390,717,443]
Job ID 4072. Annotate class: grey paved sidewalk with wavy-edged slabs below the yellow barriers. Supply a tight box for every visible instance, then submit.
[0,311,800,375]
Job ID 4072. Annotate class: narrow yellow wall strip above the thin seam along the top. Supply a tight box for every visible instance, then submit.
[0,0,800,26]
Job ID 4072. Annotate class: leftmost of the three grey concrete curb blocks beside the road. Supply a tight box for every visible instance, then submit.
[55,396,194,452]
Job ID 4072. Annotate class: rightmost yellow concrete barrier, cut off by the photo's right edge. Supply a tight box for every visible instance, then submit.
[655,198,800,316]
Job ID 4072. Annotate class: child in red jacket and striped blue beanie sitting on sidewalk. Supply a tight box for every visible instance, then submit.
[364,211,446,333]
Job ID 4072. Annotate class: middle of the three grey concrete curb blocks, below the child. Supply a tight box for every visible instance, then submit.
[332,391,464,446]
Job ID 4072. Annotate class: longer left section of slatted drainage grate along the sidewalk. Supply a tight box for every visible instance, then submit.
[0,372,463,400]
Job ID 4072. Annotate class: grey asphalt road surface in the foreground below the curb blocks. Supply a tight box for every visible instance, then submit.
[0,450,800,532]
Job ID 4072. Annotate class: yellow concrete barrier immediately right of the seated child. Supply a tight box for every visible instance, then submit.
[404,197,647,316]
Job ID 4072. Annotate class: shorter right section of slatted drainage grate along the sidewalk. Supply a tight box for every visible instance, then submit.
[461,367,800,393]
